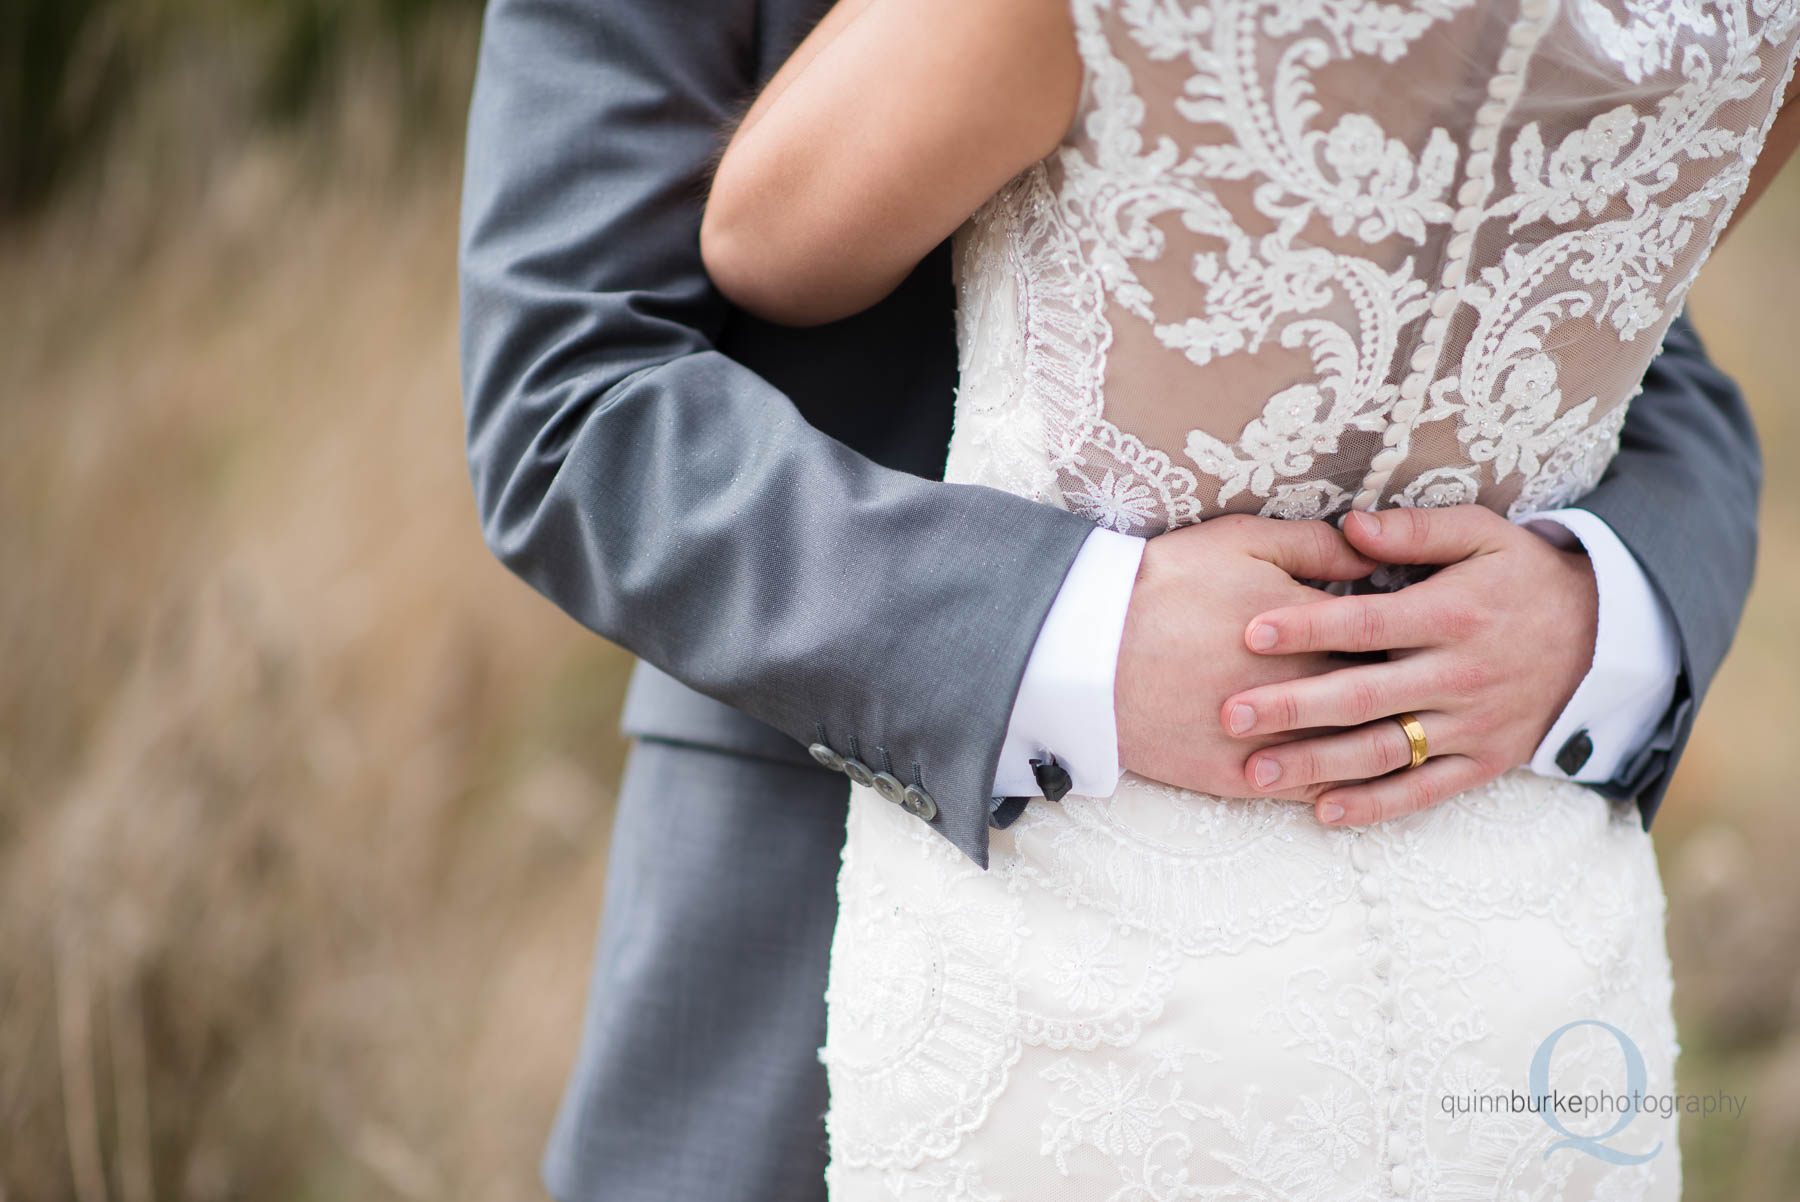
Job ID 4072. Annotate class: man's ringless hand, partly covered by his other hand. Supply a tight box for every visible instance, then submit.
[1114,515,1375,797]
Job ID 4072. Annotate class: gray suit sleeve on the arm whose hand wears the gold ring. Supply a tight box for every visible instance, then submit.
[1577,313,1762,826]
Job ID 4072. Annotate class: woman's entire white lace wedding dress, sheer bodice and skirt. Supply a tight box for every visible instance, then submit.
[821,0,1800,1202]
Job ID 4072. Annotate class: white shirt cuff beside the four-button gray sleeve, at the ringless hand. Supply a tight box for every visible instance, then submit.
[994,527,1145,797]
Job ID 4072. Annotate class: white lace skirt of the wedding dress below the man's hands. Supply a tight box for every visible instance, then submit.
[821,772,1681,1202]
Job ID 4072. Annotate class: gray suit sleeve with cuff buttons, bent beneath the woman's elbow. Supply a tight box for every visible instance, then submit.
[461,0,1091,864]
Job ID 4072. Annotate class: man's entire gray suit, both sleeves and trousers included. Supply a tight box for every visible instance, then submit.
[461,0,1760,1202]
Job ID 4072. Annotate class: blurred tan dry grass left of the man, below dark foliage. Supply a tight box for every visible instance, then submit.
[0,23,626,1202]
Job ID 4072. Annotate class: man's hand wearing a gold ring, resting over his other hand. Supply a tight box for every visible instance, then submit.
[1220,506,1598,824]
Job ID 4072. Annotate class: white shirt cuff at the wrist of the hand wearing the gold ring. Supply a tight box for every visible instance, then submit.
[1519,509,1681,785]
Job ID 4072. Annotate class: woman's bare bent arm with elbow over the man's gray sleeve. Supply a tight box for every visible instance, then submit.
[700,0,1082,326]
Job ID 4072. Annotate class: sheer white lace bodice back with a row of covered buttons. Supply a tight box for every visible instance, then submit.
[950,0,1800,534]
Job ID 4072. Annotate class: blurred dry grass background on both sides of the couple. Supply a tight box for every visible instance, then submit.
[0,0,1800,1202]
